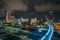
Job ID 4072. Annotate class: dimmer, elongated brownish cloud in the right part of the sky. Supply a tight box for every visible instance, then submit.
[35,3,60,12]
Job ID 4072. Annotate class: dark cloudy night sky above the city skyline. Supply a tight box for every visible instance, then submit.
[0,0,60,18]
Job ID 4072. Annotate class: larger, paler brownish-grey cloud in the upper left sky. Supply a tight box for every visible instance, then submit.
[5,0,27,11]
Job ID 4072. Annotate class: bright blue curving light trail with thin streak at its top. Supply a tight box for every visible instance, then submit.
[41,16,54,40]
